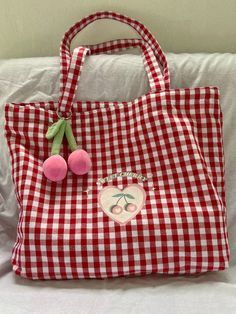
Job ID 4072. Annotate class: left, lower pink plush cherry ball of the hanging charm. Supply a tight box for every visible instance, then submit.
[43,155,67,182]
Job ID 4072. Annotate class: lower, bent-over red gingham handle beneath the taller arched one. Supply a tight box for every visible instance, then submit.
[58,38,165,117]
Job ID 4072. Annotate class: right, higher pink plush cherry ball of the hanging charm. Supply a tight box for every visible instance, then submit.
[68,149,92,175]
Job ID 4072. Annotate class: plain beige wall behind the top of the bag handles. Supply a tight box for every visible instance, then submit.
[0,0,236,58]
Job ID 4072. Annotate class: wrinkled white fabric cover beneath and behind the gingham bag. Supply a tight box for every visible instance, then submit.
[0,54,236,314]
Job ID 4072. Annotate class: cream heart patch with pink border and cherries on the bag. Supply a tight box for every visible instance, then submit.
[98,184,146,225]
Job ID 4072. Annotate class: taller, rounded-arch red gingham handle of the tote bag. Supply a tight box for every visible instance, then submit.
[60,11,170,94]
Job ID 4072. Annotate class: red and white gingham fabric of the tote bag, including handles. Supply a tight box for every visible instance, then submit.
[5,12,229,279]
